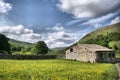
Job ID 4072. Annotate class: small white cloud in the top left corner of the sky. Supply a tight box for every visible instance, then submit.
[0,0,12,14]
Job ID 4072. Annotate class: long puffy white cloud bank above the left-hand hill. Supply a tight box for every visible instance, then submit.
[0,25,40,42]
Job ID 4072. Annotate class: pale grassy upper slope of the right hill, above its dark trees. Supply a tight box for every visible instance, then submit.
[79,23,120,43]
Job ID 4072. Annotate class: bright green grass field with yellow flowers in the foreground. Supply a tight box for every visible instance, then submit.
[0,59,117,80]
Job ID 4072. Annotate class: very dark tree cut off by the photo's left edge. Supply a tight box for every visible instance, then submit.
[0,34,10,53]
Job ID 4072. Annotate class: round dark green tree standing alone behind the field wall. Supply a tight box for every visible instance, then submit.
[32,41,48,55]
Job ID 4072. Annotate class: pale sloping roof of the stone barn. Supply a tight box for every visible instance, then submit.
[69,44,113,51]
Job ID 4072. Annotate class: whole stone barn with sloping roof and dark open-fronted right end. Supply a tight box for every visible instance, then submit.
[66,44,115,63]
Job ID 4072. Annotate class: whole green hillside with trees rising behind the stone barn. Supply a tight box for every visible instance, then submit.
[74,23,120,53]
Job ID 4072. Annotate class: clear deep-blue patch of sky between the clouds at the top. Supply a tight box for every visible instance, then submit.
[6,0,73,27]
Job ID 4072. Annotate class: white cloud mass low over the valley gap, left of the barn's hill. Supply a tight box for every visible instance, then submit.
[43,26,77,48]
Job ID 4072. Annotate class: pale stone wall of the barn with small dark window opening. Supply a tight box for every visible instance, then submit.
[66,46,96,63]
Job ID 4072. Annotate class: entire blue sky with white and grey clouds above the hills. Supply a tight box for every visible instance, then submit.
[0,0,120,48]
